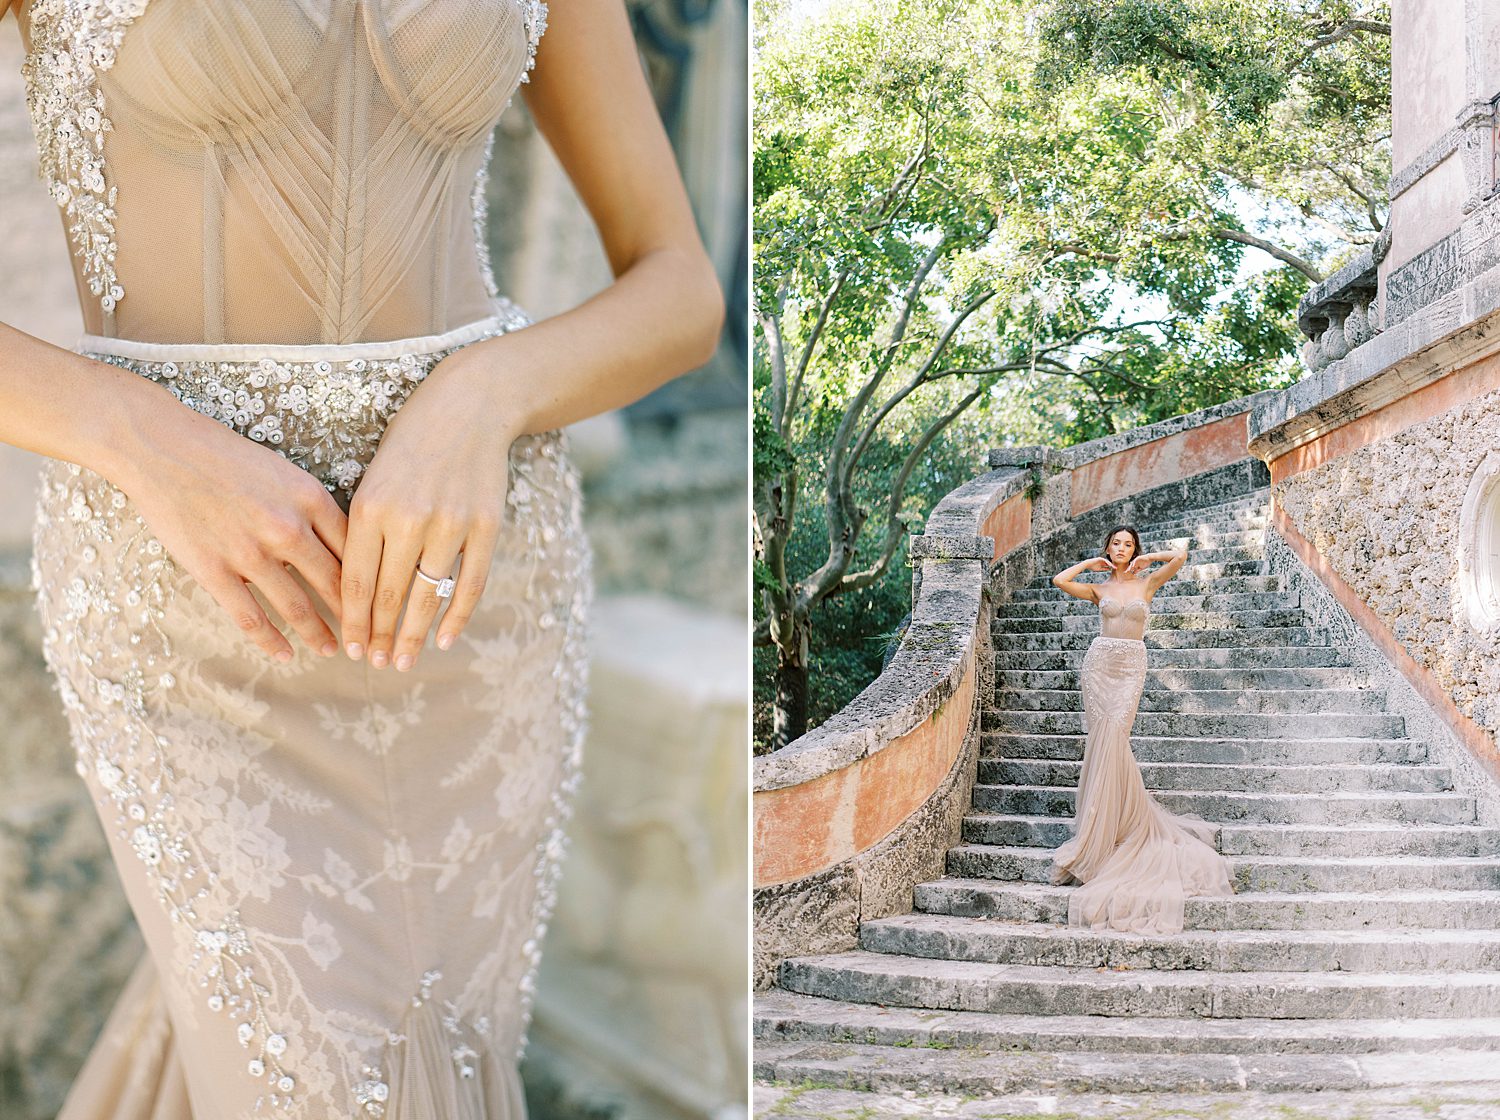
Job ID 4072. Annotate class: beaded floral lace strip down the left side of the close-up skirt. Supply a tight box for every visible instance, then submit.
[32,460,307,1107]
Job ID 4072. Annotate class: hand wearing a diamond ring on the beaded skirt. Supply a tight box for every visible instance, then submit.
[342,350,524,670]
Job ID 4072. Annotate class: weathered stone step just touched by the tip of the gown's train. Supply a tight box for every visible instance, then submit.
[860,913,1500,973]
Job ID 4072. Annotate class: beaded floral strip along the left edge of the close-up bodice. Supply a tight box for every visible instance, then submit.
[21,0,147,333]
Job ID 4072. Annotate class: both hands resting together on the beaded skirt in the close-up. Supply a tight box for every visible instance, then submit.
[126,336,527,669]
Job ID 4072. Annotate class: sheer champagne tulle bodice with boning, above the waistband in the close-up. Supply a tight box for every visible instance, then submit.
[23,0,546,343]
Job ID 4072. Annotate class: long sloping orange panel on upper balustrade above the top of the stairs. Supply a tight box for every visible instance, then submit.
[1068,412,1250,517]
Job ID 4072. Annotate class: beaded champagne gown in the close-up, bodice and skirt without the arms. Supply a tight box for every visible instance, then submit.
[21,0,593,1120]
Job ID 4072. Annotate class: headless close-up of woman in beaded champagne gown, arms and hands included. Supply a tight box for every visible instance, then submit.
[0,0,723,1120]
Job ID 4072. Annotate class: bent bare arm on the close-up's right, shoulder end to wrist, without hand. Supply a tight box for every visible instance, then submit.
[432,0,726,436]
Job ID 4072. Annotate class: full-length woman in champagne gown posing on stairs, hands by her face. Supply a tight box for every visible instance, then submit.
[1052,525,1235,934]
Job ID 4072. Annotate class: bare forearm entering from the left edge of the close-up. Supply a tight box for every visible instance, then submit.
[0,322,180,484]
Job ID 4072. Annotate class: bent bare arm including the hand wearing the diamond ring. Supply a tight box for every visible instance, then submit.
[344,0,741,669]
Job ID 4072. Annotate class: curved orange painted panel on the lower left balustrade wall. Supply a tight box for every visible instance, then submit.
[755,646,978,888]
